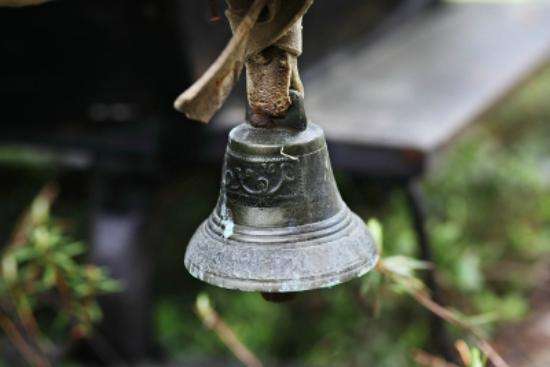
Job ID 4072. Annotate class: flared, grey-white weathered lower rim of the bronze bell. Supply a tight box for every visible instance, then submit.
[185,207,378,293]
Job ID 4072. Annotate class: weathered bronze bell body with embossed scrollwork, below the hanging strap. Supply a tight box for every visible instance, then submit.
[185,123,378,292]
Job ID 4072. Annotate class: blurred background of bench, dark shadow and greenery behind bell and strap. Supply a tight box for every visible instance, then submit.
[0,0,550,367]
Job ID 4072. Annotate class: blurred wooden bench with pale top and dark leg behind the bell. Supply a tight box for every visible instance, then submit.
[211,3,550,357]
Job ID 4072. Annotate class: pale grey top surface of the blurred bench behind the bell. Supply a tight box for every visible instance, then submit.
[306,2,550,152]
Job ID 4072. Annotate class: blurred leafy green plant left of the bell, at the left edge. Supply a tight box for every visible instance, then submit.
[0,187,120,362]
